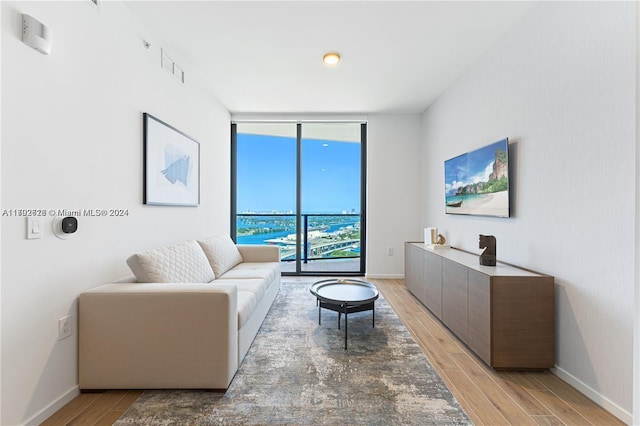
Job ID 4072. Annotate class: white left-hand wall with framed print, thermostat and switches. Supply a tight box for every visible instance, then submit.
[0,1,229,425]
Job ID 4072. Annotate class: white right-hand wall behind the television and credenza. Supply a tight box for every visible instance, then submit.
[416,2,638,422]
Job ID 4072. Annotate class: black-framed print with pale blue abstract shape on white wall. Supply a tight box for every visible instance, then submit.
[143,112,200,206]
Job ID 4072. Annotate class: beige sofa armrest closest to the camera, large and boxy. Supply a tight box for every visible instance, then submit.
[78,283,238,389]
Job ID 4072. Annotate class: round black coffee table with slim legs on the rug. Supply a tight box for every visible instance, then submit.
[310,278,379,349]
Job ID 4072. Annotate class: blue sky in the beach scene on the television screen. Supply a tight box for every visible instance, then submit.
[444,139,508,195]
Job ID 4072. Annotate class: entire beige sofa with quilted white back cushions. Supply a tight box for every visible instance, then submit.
[78,235,280,390]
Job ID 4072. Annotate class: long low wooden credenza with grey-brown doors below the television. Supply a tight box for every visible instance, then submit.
[404,242,555,369]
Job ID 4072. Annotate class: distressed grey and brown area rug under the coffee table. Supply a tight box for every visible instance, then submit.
[115,282,471,425]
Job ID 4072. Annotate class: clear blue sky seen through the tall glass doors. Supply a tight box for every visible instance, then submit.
[237,133,360,213]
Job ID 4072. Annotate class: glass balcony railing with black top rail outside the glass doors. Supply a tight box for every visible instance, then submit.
[236,213,360,263]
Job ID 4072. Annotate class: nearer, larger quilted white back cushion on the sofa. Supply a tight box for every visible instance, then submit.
[127,241,215,283]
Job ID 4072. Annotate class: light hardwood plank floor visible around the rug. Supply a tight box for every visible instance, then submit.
[43,277,624,426]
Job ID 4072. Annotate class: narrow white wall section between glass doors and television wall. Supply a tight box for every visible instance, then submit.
[367,114,423,278]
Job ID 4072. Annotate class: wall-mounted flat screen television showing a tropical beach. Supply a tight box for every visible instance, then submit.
[444,139,509,217]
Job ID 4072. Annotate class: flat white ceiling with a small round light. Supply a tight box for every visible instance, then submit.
[126,0,534,114]
